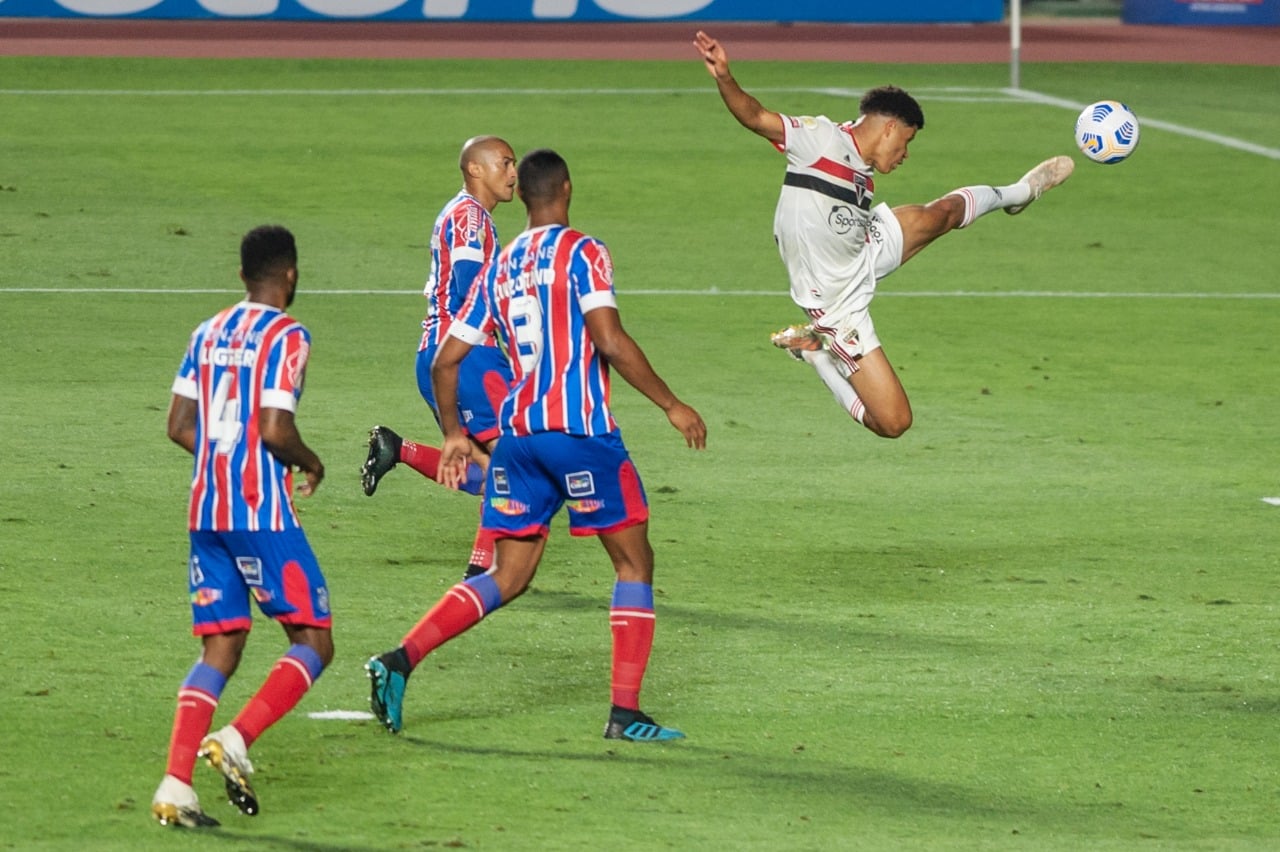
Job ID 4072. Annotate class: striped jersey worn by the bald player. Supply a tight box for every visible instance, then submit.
[417,189,499,352]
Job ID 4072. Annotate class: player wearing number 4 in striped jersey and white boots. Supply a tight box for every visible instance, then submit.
[151,225,333,828]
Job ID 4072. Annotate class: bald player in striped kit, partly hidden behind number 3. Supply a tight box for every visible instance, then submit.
[360,136,516,583]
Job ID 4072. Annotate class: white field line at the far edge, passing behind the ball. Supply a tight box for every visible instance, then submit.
[0,86,1280,160]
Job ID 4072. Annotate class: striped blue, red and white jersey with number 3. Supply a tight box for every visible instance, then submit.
[449,225,617,435]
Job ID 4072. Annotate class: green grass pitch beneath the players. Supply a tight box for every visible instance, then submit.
[0,55,1280,851]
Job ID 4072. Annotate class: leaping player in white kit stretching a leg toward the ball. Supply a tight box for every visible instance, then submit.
[694,32,1075,438]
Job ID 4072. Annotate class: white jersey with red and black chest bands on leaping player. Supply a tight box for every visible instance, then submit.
[773,115,876,312]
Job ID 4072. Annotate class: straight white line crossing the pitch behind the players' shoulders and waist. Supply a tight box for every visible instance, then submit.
[0,287,1280,299]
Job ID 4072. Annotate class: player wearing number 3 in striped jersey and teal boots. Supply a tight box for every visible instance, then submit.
[374,150,707,742]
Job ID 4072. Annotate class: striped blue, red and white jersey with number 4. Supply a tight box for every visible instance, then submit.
[173,301,311,532]
